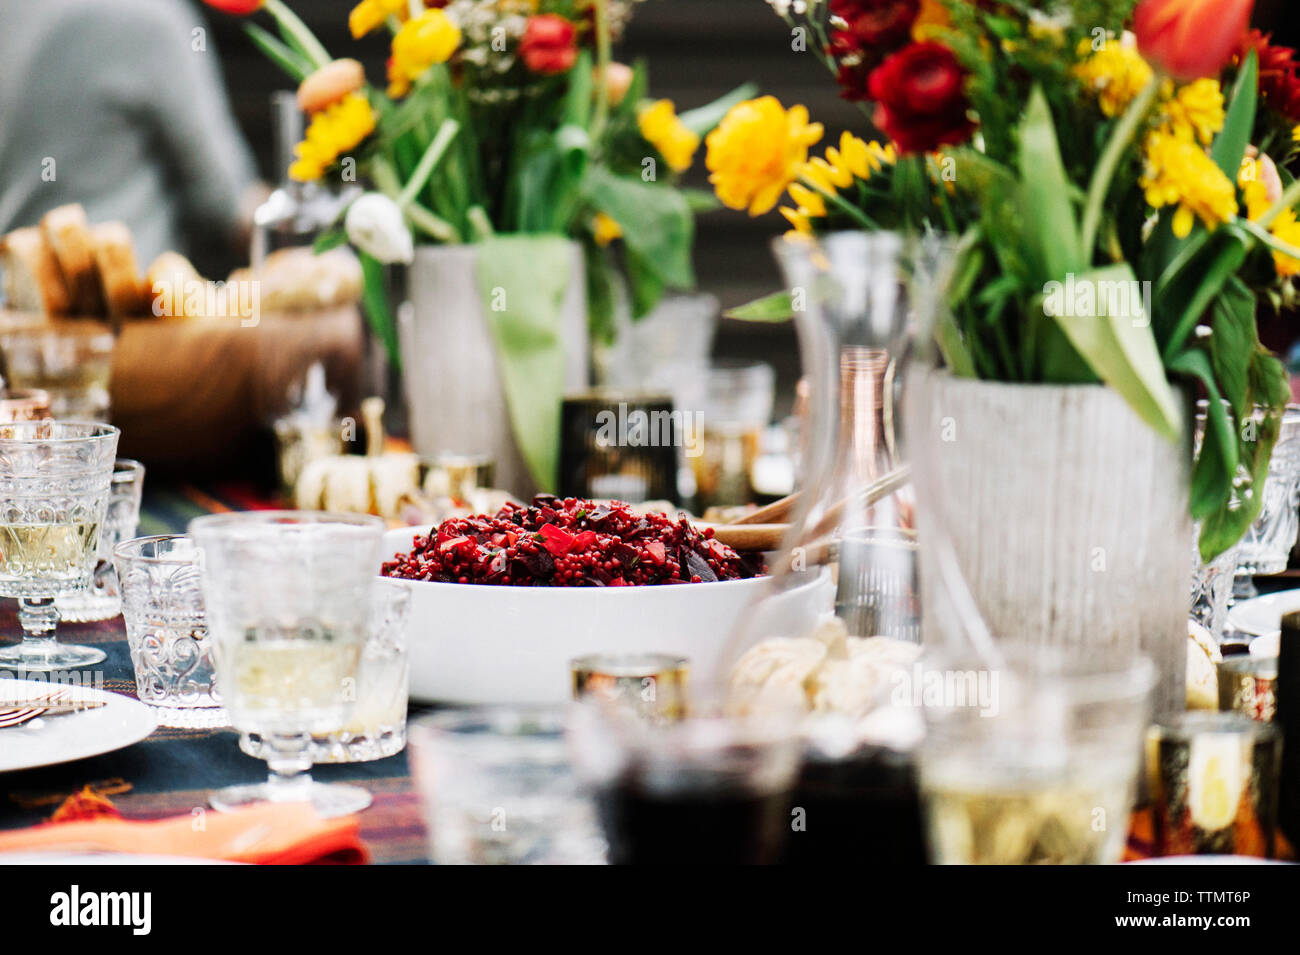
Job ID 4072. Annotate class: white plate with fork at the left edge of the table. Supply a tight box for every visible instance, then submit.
[0,680,159,773]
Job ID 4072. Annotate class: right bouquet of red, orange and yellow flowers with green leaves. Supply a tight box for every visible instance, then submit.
[706,0,1300,559]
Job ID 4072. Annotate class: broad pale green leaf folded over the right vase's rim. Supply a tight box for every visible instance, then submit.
[1045,262,1182,440]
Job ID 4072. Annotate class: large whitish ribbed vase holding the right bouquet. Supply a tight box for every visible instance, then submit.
[909,372,1192,713]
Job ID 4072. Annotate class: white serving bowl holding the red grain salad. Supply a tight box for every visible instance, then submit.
[384,526,835,704]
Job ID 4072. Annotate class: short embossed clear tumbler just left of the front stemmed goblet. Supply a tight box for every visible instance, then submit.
[113,534,230,726]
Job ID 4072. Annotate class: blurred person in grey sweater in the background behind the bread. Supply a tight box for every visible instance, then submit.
[0,0,259,262]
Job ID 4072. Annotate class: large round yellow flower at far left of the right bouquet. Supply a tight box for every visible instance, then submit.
[705,96,822,216]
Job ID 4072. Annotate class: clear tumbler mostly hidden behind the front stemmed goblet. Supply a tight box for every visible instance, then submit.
[239,578,411,763]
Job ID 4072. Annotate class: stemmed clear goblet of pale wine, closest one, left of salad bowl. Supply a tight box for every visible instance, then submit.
[190,511,385,816]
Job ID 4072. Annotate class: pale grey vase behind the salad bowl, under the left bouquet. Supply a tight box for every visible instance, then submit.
[398,243,588,500]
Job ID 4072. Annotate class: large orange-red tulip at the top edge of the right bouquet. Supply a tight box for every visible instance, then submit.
[1134,0,1255,82]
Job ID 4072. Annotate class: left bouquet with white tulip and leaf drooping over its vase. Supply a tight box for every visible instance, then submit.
[207,0,751,487]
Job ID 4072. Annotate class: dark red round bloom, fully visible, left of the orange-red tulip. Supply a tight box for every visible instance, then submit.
[867,43,975,153]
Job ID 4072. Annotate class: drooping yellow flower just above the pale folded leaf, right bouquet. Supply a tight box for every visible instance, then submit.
[1139,130,1236,239]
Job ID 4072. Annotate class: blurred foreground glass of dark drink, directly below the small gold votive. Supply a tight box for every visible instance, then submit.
[571,696,802,865]
